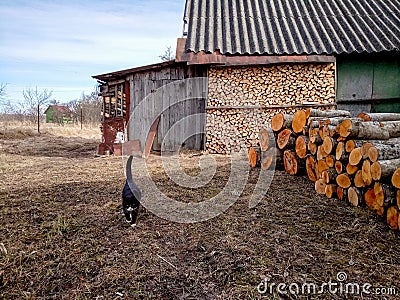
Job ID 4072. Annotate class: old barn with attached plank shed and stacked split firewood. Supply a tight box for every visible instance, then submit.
[94,0,400,153]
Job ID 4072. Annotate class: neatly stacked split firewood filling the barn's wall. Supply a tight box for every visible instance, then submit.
[205,63,335,154]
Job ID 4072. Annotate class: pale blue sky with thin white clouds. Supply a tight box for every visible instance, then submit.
[0,0,185,102]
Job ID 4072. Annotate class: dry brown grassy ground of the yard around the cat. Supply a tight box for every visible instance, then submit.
[0,123,400,299]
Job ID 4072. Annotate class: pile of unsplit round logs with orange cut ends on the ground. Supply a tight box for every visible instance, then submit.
[249,109,400,230]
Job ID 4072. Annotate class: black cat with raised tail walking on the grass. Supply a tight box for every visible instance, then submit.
[122,155,142,227]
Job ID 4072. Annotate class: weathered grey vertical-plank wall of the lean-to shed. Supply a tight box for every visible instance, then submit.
[129,65,207,151]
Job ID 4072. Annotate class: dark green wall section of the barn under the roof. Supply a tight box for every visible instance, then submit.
[337,53,400,115]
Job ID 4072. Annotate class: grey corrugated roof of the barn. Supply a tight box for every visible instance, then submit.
[184,0,400,55]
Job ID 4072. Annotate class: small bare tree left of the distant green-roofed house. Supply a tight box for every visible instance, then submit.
[22,87,53,133]
